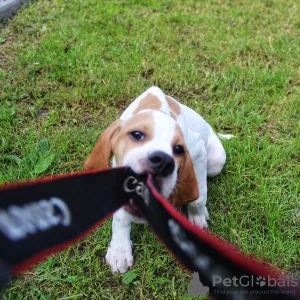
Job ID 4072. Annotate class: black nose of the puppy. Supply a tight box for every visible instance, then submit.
[148,151,175,176]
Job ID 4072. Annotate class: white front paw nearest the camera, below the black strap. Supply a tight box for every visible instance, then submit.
[105,241,133,273]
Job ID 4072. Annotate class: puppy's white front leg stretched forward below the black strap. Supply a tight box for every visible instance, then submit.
[105,208,133,273]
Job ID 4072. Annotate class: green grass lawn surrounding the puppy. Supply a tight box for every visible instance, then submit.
[0,0,300,300]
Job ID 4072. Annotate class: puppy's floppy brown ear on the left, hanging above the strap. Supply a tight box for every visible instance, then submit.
[83,120,122,170]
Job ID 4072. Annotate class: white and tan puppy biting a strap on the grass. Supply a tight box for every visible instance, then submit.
[84,87,226,273]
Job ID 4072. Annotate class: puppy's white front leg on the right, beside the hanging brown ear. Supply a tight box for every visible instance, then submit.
[187,141,209,227]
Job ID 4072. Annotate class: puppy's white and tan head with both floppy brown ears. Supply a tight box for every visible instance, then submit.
[84,96,199,206]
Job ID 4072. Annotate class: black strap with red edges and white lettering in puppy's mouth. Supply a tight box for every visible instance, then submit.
[0,168,300,299]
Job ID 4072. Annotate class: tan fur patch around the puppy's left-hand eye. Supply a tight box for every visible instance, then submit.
[113,112,154,165]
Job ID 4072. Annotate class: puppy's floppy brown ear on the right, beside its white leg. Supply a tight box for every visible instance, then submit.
[170,147,199,206]
